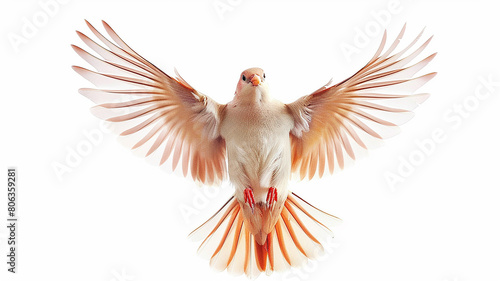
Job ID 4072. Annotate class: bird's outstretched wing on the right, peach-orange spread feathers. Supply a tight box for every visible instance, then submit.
[287,27,436,179]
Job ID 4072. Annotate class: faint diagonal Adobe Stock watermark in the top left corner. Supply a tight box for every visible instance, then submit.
[7,0,71,53]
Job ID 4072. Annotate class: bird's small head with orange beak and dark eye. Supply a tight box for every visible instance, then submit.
[235,67,268,101]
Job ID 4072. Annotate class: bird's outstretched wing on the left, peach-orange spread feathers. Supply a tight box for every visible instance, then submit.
[72,21,226,184]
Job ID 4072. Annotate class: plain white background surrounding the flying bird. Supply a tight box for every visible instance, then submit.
[0,0,500,281]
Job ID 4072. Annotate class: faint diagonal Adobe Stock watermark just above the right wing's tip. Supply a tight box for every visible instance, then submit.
[340,0,403,62]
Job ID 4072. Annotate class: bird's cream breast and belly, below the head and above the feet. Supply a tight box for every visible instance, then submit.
[221,97,292,203]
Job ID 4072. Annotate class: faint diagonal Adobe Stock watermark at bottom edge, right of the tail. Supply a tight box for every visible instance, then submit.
[282,237,340,281]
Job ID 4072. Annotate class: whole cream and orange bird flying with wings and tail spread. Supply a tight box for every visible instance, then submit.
[71,21,437,278]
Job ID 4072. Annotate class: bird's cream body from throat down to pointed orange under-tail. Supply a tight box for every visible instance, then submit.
[221,69,293,244]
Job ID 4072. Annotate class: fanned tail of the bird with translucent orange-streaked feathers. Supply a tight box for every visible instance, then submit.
[190,193,340,278]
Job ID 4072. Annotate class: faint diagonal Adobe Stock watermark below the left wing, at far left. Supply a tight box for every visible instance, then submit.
[51,120,110,182]
